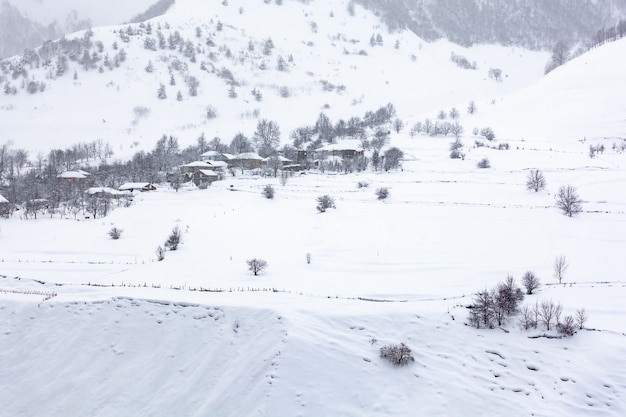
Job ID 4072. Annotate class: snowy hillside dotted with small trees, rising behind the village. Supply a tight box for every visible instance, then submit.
[0,0,547,157]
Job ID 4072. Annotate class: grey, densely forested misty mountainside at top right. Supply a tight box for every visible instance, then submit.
[356,0,626,49]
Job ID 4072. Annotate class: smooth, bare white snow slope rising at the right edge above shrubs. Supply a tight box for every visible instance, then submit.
[470,39,626,146]
